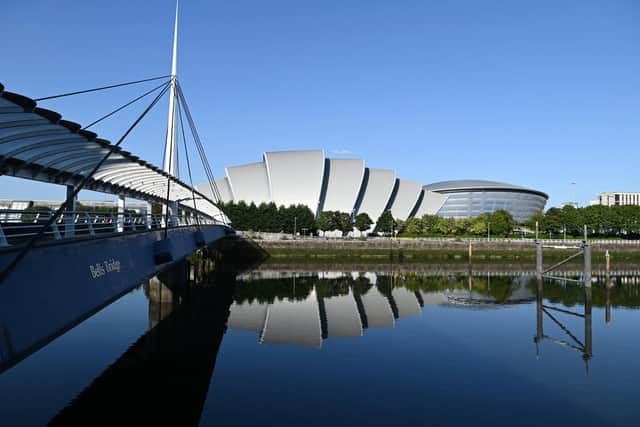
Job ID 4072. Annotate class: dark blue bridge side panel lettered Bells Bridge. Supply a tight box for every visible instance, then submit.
[0,225,233,372]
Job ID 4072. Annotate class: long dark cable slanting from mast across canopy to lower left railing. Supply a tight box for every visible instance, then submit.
[0,85,169,285]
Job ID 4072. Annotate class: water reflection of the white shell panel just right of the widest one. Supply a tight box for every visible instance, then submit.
[324,289,362,338]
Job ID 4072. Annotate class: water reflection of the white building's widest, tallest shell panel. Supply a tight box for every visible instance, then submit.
[260,289,322,348]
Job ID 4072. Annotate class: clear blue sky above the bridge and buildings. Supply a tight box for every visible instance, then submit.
[0,0,640,206]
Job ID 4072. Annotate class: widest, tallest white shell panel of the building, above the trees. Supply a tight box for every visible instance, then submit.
[264,150,324,214]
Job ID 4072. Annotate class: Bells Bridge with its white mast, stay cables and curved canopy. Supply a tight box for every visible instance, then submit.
[0,0,240,372]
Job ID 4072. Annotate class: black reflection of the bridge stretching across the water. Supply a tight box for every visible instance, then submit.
[45,239,261,426]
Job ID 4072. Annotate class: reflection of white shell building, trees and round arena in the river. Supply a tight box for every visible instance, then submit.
[229,271,535,348]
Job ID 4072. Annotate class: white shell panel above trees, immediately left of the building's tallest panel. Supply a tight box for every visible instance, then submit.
[227,162,271,205]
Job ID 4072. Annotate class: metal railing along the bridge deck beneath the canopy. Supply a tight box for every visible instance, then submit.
[0,209,216,247]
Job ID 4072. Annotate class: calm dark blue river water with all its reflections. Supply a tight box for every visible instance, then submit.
[0,268,640,426]
